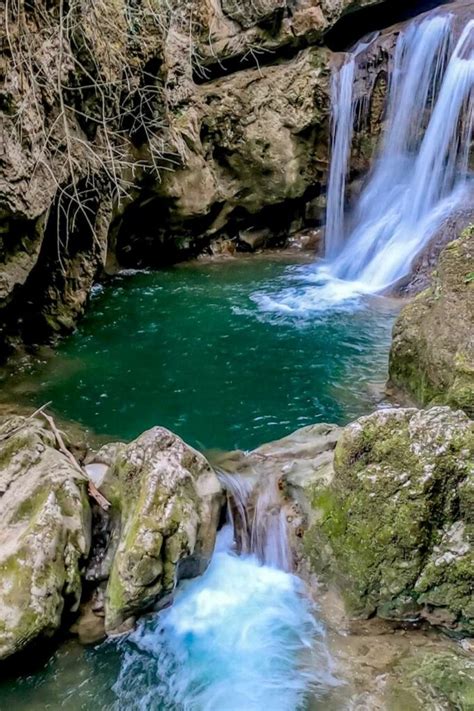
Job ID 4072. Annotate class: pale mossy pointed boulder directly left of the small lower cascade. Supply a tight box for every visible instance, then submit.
[99,427,223,633]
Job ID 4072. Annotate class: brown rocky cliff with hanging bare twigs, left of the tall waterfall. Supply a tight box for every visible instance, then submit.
[0,0,394,354]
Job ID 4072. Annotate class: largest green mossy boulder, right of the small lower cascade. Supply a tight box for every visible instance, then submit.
[304,407,474,633]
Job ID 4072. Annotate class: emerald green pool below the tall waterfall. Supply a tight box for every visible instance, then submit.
[3,258,395,449]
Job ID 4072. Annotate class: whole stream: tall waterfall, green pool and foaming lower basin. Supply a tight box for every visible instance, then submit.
[0,6,474,711]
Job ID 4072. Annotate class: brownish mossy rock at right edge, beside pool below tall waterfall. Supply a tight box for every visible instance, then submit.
[390,226,474,417]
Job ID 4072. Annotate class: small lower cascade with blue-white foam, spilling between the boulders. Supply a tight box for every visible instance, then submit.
[114,473,336,711]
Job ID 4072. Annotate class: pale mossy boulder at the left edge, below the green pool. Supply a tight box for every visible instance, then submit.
[0,417,90,659]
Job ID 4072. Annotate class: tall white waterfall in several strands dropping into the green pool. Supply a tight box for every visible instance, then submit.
[321,15,474,296]
